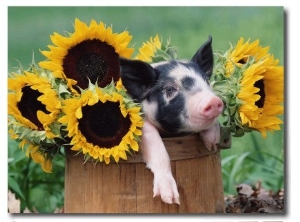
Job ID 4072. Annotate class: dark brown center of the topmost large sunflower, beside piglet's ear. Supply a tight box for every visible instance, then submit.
[62,39,120,89]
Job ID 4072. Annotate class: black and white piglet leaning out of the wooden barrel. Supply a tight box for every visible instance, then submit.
[120,37,223,204]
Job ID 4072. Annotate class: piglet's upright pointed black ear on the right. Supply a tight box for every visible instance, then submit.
[191,36,214,78]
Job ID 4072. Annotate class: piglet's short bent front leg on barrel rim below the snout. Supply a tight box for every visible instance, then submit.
[200,122,220,151]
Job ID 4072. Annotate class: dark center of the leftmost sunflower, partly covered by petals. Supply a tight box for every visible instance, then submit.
[17,86,49,130]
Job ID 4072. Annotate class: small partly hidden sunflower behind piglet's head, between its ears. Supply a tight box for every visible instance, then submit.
[134,35,177,63]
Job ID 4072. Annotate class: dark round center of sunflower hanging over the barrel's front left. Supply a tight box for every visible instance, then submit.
[78,102,130,148]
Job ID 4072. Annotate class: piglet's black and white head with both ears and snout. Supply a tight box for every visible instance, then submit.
[120,37,223,134]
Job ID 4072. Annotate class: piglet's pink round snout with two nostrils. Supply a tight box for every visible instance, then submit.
[201,96,223,119]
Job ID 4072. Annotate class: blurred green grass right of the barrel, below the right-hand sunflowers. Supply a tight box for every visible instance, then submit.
[221,131,285,194]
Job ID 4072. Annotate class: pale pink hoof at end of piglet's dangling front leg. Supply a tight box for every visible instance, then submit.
[153,175,180,204]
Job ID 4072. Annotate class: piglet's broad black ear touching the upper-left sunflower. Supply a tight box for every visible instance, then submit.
[120,58,157,102]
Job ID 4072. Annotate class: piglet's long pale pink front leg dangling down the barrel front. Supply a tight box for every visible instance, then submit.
[141,121,180,204]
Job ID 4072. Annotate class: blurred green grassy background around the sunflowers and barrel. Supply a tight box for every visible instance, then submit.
[8,6,285,213]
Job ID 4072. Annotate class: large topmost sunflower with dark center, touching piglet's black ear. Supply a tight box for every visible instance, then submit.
[39,19,134,93]
